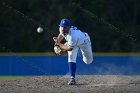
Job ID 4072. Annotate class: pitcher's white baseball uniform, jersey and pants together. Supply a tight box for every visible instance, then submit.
[60,26,93,64]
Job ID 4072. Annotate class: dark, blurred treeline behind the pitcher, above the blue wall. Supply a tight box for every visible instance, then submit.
[0,0,140,52]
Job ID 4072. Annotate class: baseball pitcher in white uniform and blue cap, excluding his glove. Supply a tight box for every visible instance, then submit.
[53,18,93,85]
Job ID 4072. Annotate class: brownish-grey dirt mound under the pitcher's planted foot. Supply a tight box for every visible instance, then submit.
[0,75,140,93]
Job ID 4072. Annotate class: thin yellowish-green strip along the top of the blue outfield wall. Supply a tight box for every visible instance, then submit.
[0,52,140,56]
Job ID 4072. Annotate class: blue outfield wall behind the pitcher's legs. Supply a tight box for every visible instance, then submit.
[0,55,140,75]
